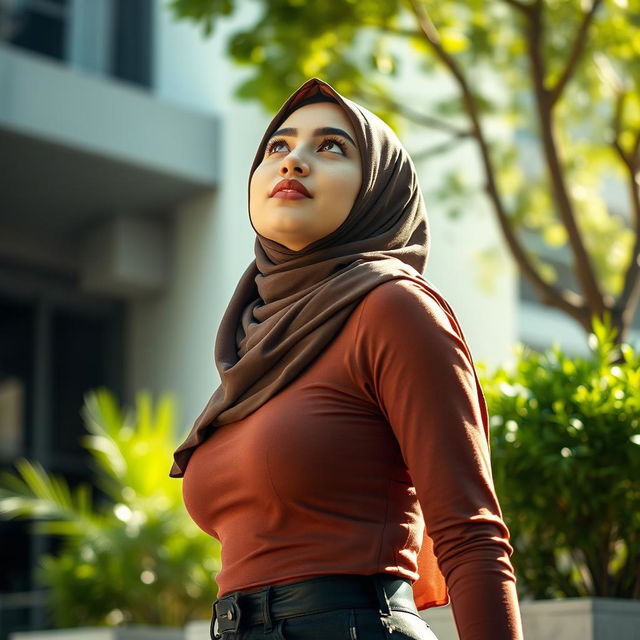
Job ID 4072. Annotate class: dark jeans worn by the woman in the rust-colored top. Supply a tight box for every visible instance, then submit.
[211,576,438,640]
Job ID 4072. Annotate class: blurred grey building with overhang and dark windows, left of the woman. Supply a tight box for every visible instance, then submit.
[0,0,267,638]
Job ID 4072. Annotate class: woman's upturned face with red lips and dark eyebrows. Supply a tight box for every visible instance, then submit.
[249,102,362,251]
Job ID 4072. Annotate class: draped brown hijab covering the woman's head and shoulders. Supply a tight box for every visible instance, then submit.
[169,78,429,478]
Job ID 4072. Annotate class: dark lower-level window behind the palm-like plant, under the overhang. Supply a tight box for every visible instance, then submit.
[0,274,124,640]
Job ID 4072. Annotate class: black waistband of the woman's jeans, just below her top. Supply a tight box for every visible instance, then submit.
[210,573,418,639]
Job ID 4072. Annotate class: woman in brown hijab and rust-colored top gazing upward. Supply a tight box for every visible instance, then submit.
[170,78,522,640]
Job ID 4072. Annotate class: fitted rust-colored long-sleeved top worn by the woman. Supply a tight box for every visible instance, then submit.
[183,279,522,640]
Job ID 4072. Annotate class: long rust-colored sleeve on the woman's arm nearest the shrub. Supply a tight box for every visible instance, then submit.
[356,280,523,640]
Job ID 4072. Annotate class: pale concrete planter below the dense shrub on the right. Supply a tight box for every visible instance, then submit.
[420,598,640,640]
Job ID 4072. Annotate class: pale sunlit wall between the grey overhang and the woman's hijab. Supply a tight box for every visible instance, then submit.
[127,1,270,440]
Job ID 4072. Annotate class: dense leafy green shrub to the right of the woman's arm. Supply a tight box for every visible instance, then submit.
[478,317,640,598]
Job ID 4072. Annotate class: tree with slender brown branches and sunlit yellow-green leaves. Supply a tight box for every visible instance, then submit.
[167,0,640,341]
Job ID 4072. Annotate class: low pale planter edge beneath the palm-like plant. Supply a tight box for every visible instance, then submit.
[9,625,182,640]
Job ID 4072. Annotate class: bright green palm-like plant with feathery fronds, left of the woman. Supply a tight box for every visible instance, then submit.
[0,389,220,627]
